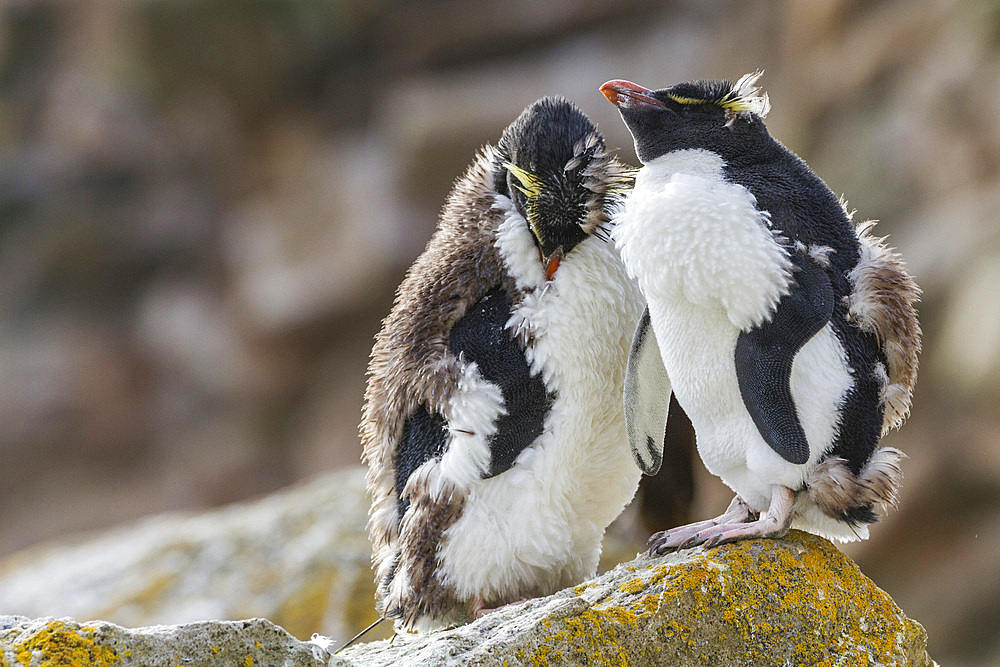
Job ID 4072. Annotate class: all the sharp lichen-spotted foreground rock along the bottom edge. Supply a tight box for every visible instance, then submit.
[0,531,934,667]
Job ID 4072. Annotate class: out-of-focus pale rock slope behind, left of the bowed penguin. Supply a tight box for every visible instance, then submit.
[0,467,382,641]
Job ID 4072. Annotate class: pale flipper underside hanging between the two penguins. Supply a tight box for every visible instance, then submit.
[623,306,671,475]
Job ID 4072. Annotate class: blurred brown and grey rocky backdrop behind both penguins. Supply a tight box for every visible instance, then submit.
[0,0,1000,664]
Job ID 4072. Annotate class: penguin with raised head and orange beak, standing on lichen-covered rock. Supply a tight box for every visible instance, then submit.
[601,72,921,555]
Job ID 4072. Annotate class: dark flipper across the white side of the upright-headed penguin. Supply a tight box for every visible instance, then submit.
[735,251,834,464]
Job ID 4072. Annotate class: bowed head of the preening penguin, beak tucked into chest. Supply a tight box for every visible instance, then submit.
[494,97,631,279]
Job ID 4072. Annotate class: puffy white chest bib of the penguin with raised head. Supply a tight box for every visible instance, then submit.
[613,150,792,329]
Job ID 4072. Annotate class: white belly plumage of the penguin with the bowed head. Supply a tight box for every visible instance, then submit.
[438,201,642,601]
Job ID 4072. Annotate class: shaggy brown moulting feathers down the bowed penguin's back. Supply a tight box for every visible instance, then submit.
[360,146,513,628]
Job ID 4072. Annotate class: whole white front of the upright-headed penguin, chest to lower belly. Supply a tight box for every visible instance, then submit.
[613,150,852,511]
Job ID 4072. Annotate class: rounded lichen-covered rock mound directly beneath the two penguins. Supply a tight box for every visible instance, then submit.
[343,531,933,666]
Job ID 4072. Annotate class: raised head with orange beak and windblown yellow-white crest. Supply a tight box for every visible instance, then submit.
[601,71,773,165]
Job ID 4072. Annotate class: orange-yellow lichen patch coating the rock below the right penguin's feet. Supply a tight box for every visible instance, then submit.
[531,531,922,666]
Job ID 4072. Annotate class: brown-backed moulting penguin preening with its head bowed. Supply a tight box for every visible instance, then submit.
[360,97,642,632]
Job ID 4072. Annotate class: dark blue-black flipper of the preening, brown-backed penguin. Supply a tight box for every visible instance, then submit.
[448,287,553,478]
